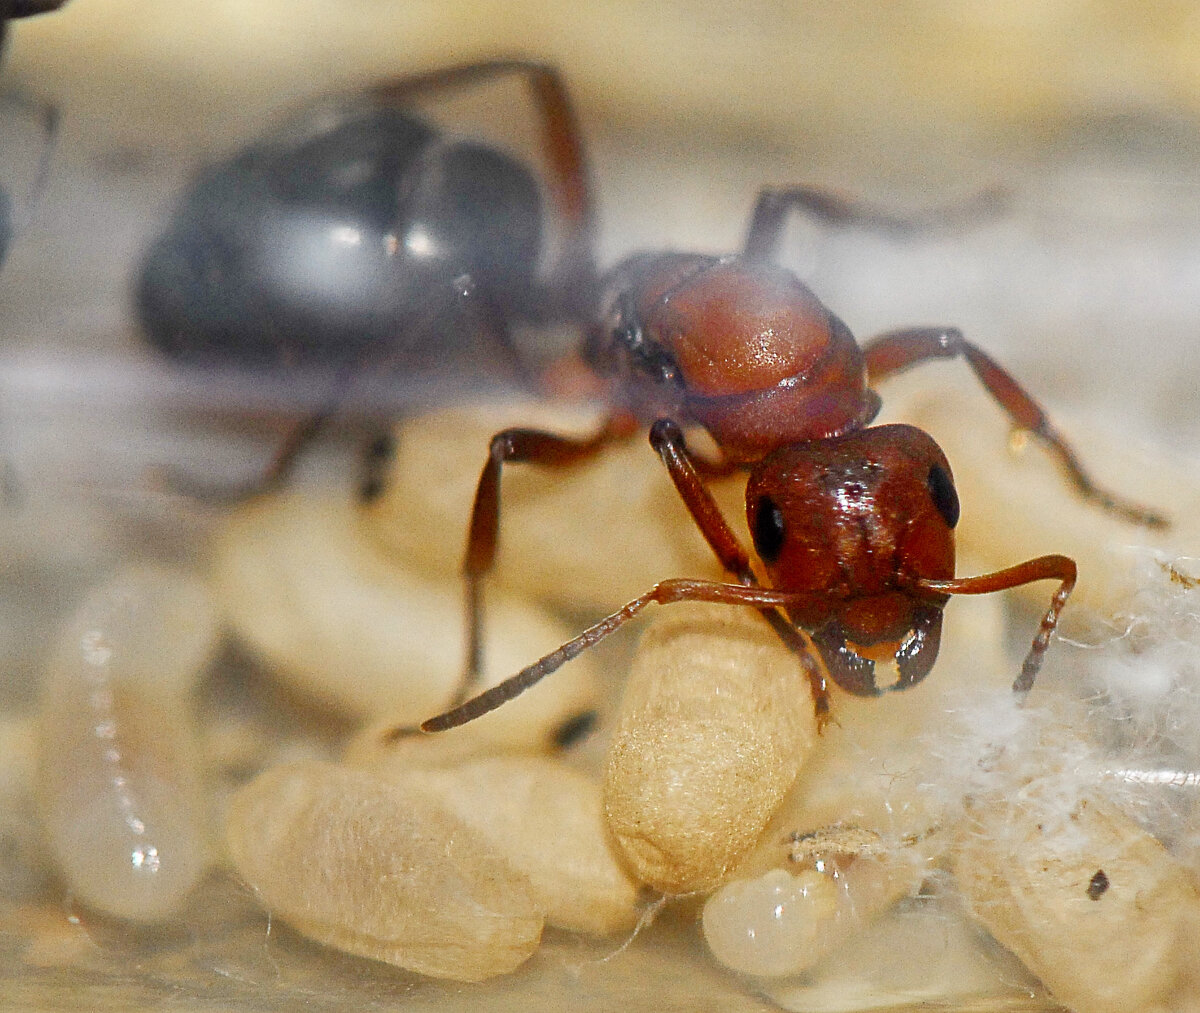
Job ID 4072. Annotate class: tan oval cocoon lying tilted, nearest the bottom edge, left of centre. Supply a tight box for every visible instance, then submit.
[227,761,542,982]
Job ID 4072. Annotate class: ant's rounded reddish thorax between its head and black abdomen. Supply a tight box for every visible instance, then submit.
[593,253,878,461]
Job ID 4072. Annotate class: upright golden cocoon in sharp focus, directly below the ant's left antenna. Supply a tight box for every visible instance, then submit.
[604,605,816,893]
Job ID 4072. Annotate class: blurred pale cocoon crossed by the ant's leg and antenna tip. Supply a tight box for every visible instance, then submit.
[212,494,595,743]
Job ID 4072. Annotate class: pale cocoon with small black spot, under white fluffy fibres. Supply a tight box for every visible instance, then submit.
[954,780,1200,1013]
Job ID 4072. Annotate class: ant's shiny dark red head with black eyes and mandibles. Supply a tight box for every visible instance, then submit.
[746,425,959,696]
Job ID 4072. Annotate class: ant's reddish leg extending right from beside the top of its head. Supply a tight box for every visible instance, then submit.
[863,328,1168,528]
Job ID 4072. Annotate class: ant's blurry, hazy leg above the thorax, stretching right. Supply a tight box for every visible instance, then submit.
[742,186,1008,263]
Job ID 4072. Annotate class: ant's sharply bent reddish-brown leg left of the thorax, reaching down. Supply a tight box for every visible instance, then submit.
[456,415,631,700]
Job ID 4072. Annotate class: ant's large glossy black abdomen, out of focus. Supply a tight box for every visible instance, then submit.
[136,102,541,370]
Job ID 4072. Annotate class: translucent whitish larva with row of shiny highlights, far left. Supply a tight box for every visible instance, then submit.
[37,568,216,921]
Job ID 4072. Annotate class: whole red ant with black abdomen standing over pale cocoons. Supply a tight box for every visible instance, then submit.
[138,61,1164,731]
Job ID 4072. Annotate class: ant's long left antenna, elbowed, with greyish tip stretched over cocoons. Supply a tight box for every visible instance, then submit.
[421,580,825,732]
